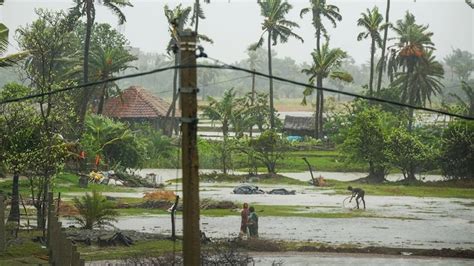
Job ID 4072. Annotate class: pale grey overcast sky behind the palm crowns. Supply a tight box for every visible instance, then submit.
[0,0,474,63]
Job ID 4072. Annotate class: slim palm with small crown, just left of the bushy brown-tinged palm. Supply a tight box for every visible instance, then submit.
[357,7,384,96]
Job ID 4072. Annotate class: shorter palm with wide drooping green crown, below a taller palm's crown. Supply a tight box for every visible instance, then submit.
[301,43,352,138]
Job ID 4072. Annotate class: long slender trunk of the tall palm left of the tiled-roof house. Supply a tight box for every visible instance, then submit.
[79,0,94,132]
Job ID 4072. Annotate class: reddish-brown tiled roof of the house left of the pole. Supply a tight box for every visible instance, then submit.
[103,86,180,118]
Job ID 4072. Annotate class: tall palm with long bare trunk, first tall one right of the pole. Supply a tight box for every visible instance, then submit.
[250,0,303,129]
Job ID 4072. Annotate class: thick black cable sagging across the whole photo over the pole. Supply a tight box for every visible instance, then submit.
[0,62,474,120]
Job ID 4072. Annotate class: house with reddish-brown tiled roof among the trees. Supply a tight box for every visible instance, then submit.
[103,86,180,131]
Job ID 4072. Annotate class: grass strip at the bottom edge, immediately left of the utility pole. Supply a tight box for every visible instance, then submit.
[79,240,182,261]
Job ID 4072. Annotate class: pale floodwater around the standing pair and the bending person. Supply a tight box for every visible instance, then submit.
[62,183,474,249]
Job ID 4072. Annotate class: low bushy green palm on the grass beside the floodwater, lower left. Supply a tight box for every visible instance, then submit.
[73,191,118,229]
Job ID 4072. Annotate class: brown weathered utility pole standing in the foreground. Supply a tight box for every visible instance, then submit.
[179,31,201,266]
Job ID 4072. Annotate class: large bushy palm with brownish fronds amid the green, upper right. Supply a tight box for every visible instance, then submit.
[389,12,436,130]
